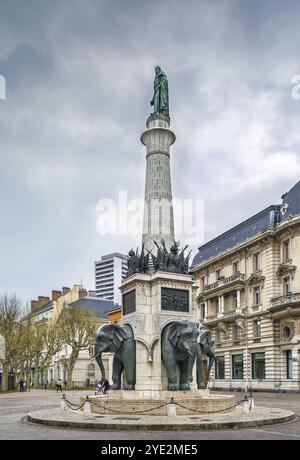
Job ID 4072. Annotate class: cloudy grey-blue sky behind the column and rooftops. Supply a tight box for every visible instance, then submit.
[0,0,300,302]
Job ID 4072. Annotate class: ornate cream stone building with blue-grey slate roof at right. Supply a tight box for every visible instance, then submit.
[192,182,300,391]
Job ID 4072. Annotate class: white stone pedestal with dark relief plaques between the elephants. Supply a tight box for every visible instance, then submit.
[120,272,197,392]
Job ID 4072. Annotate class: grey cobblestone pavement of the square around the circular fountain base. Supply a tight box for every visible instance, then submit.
[0,390,300,441]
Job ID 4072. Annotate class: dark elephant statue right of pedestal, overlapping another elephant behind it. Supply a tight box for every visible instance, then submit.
[161,320,200,391]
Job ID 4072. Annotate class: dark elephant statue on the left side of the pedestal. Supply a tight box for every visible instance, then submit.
[94,324,136,390]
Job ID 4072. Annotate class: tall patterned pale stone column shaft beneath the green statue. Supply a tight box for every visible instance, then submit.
[141,114,176,250]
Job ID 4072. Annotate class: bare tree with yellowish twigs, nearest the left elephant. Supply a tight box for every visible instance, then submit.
[57,307,100,387]
